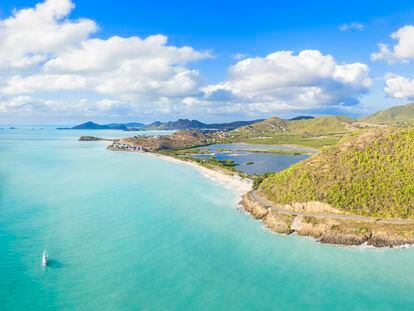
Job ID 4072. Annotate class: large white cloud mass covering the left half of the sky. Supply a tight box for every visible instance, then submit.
[0,0,211,119]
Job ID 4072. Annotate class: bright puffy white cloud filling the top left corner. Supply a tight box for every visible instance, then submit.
[0,0,97,68]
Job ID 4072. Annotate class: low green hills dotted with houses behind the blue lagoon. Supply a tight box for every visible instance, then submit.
[115,116,378,151]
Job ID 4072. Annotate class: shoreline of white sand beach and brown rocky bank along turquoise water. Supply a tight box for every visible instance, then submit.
[104,140,414,248]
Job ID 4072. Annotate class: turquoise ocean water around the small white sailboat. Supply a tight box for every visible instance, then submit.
[0,128,414,310]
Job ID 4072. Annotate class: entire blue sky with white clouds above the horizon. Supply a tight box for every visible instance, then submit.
[0,0,414,123]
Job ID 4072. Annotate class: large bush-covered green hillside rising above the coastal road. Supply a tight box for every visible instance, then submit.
[259,129,414,218]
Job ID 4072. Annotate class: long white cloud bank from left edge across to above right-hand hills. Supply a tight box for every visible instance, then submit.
[0,0,372,119]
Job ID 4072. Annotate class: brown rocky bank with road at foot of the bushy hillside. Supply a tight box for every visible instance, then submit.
[240,192,414,247]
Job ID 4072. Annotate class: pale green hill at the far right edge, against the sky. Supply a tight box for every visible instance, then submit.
[361,103,414,125]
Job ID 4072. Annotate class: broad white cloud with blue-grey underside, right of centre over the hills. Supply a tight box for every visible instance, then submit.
[192,50,372,113]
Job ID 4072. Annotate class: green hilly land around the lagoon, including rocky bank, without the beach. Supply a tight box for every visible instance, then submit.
[83,105,414,247]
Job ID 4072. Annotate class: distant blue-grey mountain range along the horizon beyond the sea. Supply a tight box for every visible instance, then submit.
[59,119,263,131]
